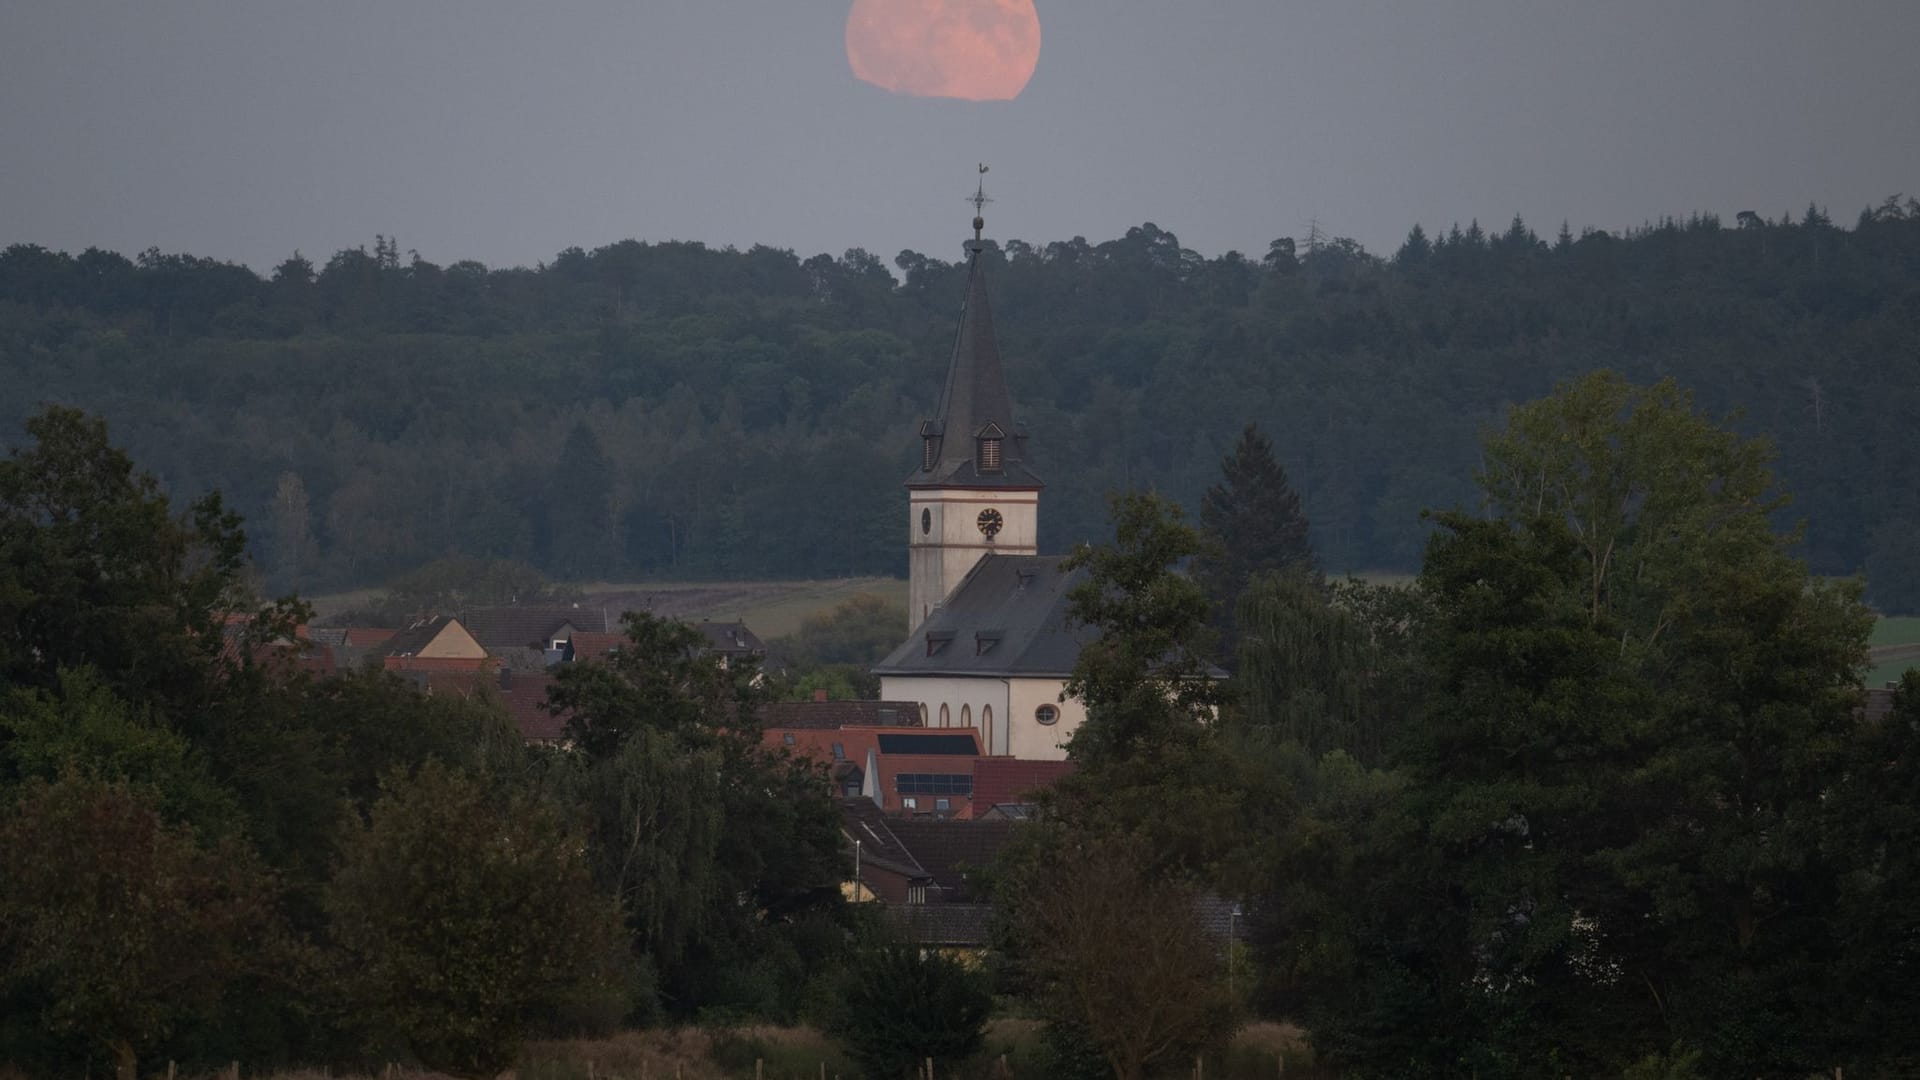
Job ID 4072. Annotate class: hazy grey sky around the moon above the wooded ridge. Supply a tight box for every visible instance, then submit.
[0,0,1920,269]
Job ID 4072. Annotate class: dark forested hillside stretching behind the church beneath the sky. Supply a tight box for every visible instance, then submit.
[0,200,1920,607]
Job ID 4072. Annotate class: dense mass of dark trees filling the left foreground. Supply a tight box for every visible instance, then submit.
[0,409,864,1080]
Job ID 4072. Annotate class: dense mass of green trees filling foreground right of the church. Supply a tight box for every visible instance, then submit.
[998,373,1920,1080]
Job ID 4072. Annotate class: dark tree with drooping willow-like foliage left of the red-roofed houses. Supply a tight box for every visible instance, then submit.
[549,611,845,1017]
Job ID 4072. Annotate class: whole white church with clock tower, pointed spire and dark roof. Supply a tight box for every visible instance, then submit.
[874,196,1094,761]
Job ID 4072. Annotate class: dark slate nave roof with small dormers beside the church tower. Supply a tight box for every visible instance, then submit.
[874,552,1098,678]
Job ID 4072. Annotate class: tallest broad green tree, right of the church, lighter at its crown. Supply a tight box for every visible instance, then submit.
[1259,373,1870,1076]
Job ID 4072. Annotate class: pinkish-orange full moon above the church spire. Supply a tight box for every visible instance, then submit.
[847,0,1041,102]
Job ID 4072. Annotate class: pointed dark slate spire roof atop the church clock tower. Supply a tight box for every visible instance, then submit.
[906,240,1044,490]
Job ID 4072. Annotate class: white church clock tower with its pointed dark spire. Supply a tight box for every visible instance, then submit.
[906,178,1044,630]
